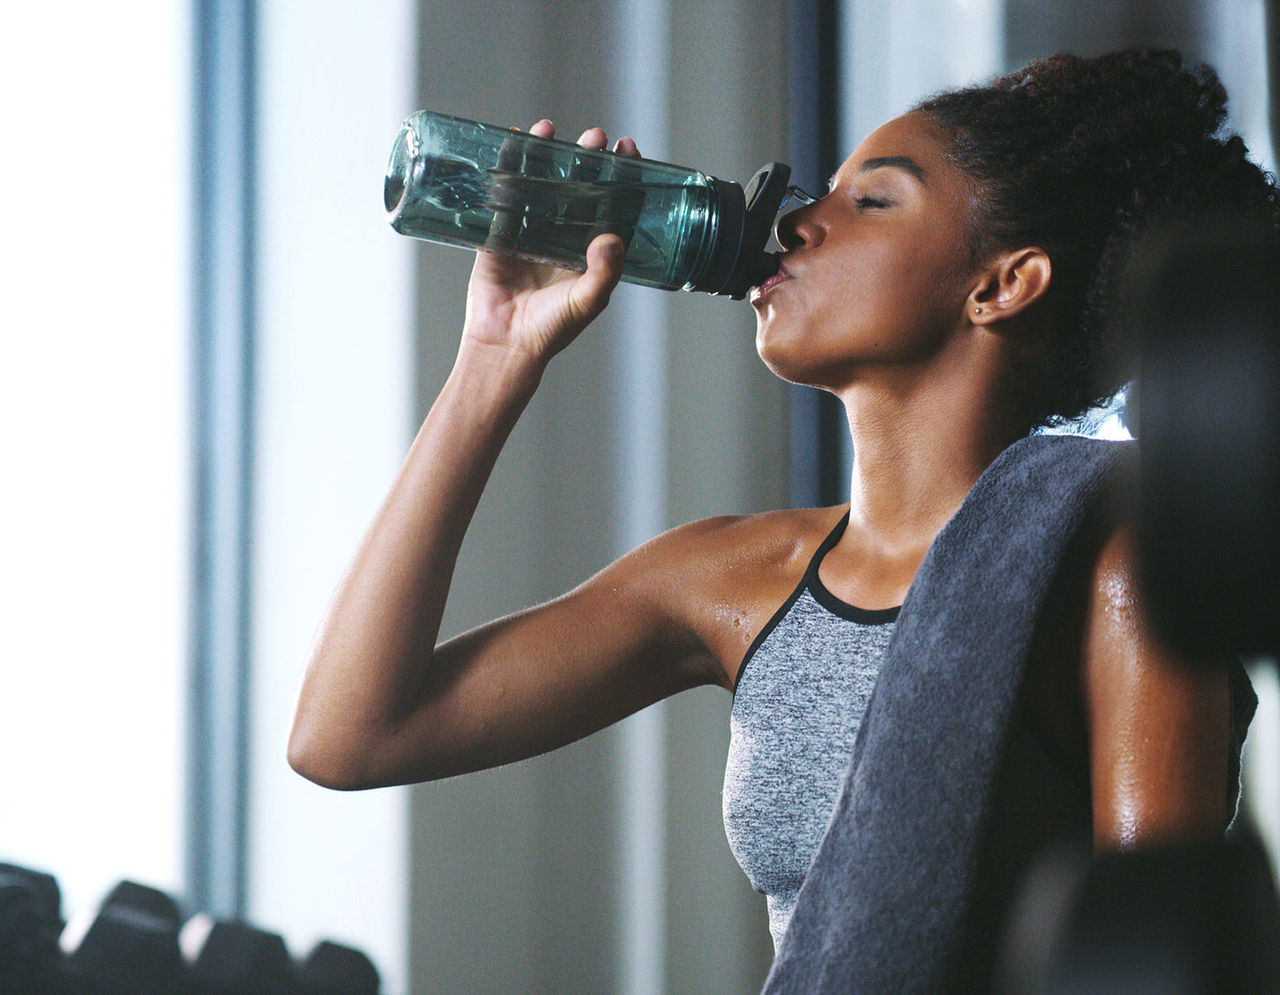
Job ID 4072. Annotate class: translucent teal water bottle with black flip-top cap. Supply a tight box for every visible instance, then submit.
[383,110,791,298]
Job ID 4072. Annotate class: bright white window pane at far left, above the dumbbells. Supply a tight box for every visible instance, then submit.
[0,0,191,912]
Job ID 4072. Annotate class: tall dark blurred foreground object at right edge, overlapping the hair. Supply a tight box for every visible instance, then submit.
[1120,215,1280,659]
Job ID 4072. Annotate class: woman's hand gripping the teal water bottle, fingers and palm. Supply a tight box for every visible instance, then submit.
[463,119,639,364]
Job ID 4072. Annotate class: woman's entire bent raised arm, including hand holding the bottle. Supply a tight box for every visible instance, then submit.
[289,122,716,789]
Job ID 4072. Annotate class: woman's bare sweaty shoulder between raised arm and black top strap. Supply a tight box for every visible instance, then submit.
[614,507,845,688]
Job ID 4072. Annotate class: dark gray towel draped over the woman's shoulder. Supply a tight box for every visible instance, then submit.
[764,435,1133,995]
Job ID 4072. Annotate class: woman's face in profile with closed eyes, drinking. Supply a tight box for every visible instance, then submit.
[751,113,974,389]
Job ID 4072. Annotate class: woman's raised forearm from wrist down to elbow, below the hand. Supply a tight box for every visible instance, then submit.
[289,338,541,785]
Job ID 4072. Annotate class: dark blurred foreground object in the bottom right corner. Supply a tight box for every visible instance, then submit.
[997,835,1280,995]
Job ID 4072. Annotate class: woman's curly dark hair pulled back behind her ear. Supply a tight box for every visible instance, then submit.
[915,49,1280,428]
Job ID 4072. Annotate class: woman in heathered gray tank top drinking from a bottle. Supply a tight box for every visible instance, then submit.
[289,53,1276,983]
